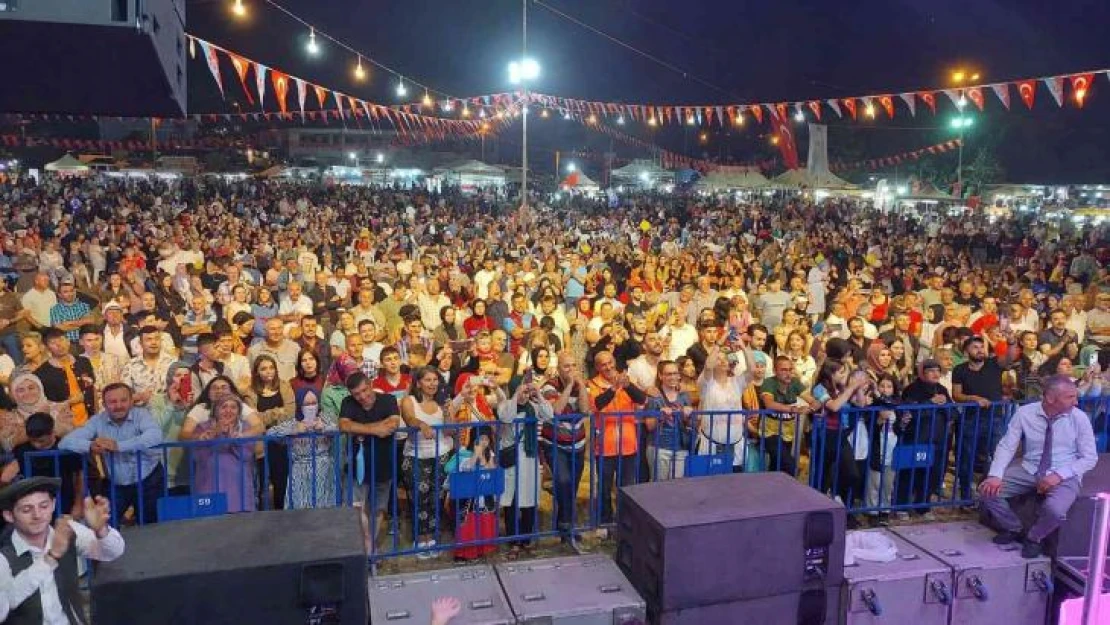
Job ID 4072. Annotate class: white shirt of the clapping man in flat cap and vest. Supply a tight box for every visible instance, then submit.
[0,521,123,625]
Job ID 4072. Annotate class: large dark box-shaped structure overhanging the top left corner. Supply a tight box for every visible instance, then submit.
[0,0,189,118]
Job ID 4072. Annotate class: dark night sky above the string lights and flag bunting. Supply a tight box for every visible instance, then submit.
[188,0,1110,182]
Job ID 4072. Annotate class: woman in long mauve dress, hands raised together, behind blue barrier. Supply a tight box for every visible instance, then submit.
[193,395,255,512]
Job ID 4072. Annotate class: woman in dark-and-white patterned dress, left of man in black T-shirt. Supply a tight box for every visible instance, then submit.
[266,386,339,510]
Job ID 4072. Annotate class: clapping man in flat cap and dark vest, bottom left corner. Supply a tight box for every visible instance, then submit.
[0,477,123,625]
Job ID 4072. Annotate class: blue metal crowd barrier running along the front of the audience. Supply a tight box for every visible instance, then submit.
[22,396,1110,560]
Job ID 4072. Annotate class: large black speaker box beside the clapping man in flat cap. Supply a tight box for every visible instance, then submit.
[92,508,369,625]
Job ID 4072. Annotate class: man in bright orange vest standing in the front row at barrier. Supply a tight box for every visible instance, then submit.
[589,352,647,524]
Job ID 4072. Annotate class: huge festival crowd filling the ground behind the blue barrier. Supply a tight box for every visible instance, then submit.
[0,172,1110,558]
